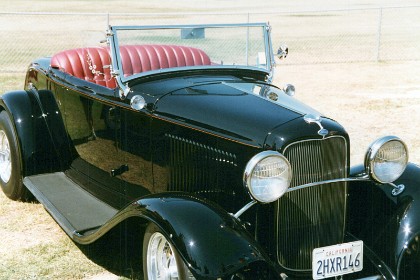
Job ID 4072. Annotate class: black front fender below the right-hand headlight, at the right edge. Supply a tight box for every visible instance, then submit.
[347,164,420,277]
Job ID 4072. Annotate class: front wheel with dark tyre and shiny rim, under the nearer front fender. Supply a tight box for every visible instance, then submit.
[143,223,195,280]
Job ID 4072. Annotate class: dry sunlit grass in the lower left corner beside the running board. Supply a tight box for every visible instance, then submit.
[0,193,115,279]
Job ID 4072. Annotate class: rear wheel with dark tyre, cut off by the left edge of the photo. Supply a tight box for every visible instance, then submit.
[0,111,27,200]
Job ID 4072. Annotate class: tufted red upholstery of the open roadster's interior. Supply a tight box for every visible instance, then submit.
[51,45,211,88]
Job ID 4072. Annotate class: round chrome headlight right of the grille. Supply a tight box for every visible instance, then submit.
[365,136,408,184]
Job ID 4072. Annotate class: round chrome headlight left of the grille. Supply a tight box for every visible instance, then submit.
[244,151,292,203]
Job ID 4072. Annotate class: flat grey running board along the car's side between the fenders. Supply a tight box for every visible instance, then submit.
[23,172,118,239]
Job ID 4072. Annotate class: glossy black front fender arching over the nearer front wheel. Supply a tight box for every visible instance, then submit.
[133,194,279,279]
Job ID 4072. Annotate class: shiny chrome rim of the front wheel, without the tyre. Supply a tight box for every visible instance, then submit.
[147,232,179,280]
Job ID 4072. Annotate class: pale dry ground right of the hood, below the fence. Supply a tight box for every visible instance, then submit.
[276,61,420,165]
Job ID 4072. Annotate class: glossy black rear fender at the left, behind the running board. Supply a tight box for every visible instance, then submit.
[0,90,70,177]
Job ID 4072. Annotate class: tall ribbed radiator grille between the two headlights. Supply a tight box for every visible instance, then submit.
[277,137,347,270]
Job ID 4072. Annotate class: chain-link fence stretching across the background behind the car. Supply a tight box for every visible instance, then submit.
[0,6,420,92]
